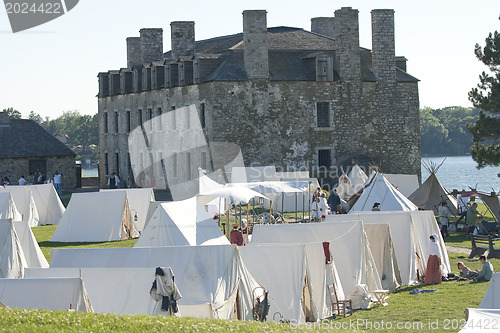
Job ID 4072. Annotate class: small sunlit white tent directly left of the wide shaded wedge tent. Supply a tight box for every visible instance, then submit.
[29,184,66,225]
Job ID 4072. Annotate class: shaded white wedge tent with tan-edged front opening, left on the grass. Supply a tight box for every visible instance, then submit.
[51,191,139,242]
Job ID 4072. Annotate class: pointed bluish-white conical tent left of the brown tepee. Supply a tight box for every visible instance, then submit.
[349,172,418,213]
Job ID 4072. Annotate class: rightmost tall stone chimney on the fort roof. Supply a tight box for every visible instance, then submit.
[371,9,396,83]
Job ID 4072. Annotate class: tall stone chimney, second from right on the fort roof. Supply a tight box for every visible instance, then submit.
[334,7,361,81]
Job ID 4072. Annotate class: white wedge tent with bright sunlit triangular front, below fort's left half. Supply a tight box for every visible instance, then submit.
[134,197,229,247]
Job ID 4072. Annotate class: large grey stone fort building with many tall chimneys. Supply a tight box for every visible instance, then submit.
[98,7,420,186]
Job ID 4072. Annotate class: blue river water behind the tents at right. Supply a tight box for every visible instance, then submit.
[422,156,500,193]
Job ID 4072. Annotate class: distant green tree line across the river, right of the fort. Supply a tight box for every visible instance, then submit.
[420,106,479,156]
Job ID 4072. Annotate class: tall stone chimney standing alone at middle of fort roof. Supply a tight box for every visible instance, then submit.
[243,10,269,79]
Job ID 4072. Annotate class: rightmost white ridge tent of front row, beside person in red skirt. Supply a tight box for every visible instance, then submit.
[325,211,451,285]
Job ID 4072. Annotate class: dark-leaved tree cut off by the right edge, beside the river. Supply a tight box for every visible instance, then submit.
[467,17,500,177]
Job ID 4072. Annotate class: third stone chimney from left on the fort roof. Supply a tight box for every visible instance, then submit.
[170,21,196,60]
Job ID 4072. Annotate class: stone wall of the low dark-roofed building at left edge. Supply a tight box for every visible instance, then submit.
[0,156,76,190]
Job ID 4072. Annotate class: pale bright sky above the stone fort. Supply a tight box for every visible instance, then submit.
[0,0,500,119]
